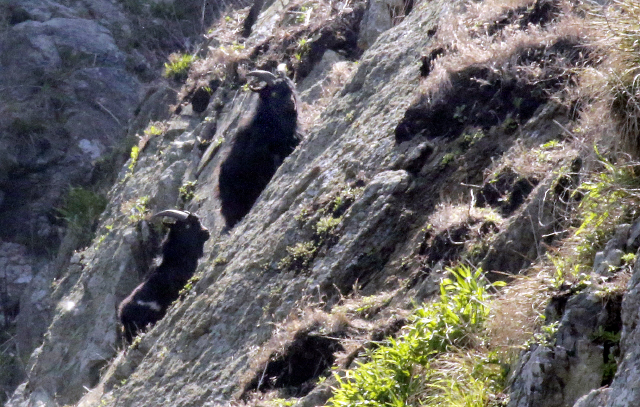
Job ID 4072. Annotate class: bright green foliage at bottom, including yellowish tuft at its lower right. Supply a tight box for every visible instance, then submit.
[329,266,504,407]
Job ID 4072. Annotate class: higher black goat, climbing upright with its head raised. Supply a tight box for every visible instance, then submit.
[218,71,301,228]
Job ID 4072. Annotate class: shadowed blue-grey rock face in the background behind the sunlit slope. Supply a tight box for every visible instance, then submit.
[0,0,245,403]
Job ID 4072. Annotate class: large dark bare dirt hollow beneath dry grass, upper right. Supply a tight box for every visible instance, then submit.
[395,39,586,143]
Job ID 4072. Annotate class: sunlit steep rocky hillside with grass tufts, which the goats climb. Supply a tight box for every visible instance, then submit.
[7,0,640,407]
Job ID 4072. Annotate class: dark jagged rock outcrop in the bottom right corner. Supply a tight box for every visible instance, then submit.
[509,217,640,407]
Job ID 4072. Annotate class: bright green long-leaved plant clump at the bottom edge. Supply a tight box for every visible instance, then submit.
[329,266,502,407]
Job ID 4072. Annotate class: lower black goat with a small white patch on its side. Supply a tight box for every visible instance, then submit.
[118,209,209,343]
